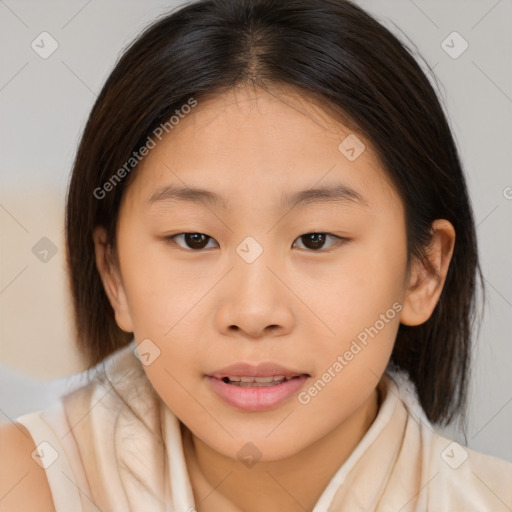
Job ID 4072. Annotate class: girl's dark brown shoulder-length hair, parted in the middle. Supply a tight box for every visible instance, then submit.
[66,0,483,424]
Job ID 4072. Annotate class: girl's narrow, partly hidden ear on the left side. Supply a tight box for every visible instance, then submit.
[92,226,133,332]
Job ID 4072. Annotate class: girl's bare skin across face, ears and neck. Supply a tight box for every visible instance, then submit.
[94,88,455,512]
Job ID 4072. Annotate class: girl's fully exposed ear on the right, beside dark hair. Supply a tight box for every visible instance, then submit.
[400,219,455,326]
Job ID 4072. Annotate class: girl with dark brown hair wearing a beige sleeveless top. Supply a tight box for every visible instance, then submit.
[0,0,512,512]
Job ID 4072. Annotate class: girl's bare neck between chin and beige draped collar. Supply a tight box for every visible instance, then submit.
[181,389,379,512]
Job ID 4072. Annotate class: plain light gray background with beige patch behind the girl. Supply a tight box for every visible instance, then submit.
[0,0,512,461]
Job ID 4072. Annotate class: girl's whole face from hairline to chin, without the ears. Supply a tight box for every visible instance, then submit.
[97,89,424,460]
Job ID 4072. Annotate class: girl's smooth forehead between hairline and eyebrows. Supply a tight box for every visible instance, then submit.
[122,88,393,212]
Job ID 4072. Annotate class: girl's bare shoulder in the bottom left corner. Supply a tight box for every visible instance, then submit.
[0,423,55,512]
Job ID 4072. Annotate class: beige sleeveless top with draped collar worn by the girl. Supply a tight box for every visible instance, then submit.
[15,340,512,512]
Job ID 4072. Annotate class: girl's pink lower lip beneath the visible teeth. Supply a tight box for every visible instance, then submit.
[206,375,308,411]
